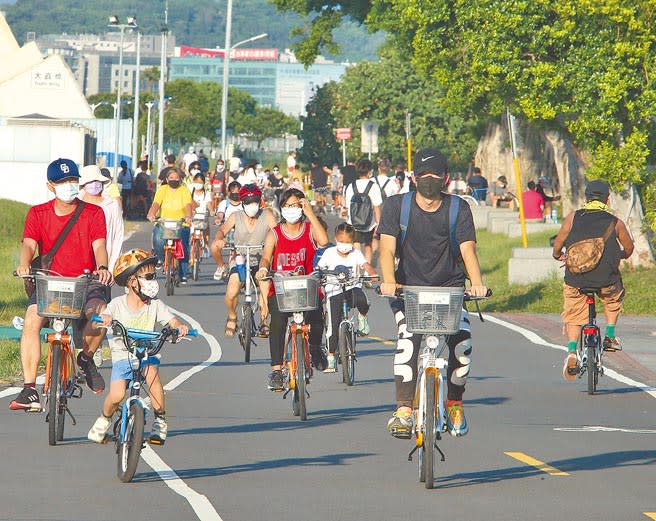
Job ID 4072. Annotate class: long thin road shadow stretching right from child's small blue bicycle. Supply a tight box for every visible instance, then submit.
[132,452,375,483]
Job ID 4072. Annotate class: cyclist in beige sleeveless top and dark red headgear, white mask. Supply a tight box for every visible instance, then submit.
[212,184,277,337]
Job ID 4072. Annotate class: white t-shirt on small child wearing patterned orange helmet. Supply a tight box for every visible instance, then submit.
[103,295,174,363]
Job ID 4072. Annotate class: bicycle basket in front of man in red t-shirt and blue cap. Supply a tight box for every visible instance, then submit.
[34,273,89,319]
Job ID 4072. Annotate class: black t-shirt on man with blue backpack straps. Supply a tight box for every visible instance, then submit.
[378,194,476,287]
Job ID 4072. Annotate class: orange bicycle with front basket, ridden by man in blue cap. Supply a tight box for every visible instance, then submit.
[14,270,92,445]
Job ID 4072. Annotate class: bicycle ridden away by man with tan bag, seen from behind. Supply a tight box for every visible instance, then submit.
[576,288,604,395]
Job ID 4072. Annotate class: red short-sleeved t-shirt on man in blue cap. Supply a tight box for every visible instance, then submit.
[23,199,107,277]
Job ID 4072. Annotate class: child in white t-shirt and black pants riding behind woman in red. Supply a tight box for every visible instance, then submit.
[318,223,377,373]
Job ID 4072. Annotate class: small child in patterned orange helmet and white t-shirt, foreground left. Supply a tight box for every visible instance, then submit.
[88,249,189,445]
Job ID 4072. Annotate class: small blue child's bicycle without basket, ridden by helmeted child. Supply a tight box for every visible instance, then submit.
[91,315,198,483]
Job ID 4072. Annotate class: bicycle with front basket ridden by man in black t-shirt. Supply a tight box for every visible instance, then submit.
[382,286,492,489]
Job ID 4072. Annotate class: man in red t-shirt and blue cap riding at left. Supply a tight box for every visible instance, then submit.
[9,159,112,411]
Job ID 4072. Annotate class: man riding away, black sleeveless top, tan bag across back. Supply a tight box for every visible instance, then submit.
[553,180,634,381]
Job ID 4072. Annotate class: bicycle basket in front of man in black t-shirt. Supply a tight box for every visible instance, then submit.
[403,286,464,335]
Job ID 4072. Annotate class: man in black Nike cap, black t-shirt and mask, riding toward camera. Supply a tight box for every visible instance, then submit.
[379,148,487,438]
